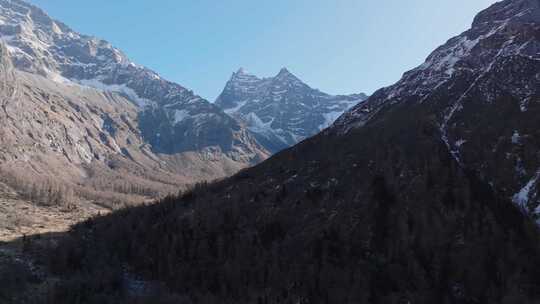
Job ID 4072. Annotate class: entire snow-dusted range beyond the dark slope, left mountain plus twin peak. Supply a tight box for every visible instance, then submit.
[0,0,365,205]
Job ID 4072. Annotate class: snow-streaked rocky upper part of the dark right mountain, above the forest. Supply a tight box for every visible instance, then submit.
[332,0,540,223]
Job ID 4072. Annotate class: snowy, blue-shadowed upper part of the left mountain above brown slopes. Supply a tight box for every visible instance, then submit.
[0,0,266,154]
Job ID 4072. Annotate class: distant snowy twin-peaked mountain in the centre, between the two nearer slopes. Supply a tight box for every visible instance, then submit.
[215,69,367,152]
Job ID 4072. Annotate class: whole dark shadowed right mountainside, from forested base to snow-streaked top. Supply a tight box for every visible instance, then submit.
[25,0,540,304]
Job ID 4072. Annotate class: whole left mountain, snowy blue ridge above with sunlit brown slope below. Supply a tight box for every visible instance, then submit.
[0,0,268,204]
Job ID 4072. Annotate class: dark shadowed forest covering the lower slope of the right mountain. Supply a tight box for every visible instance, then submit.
[13,107,540,304]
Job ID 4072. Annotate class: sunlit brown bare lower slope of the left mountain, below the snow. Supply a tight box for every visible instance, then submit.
[0,47,238,202]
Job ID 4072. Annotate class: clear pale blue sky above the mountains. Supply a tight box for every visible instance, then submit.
[29,0,496,101]
